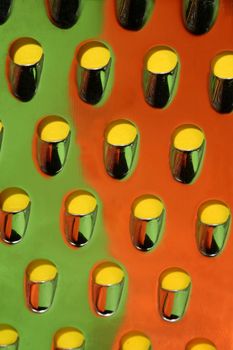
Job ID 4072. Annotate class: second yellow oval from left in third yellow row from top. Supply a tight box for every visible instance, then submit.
[65,190,97,215]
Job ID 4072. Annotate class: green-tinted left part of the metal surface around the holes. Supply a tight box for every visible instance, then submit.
[0,0,126,350]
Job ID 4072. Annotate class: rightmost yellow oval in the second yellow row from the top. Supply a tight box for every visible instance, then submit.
[173,125,205,151]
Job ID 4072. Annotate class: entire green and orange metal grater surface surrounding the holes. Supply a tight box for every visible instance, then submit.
[0,0,233,350]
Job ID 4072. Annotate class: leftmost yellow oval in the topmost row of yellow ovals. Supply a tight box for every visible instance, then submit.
[10,38,43,66]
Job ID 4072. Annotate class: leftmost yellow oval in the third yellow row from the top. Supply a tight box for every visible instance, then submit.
[0,187,30,213]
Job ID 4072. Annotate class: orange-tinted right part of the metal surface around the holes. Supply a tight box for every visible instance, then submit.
[70,0,233,350]
